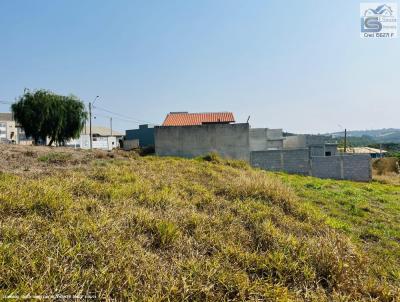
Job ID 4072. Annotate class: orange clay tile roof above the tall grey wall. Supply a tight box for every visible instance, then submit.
[162,112,235,126]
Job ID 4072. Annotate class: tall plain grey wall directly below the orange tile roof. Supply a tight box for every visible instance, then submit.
[154,124,249,161]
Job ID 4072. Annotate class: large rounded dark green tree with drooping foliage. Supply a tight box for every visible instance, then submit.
[11,90,87,145]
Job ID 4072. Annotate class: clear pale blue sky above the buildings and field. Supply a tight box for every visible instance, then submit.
[0,0,400,133]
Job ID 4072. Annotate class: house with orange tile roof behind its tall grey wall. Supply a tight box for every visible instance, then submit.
[154,112,249,161]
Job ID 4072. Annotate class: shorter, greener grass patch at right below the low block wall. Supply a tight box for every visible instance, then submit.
[280,174,400,287]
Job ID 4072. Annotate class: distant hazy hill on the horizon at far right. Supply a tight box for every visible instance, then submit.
[329,128,400,143]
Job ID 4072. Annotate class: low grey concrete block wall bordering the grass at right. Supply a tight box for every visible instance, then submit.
[250,149,372,181]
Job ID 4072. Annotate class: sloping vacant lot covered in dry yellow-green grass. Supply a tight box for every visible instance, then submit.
[0,146,400,301]
